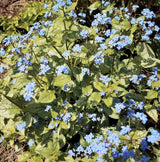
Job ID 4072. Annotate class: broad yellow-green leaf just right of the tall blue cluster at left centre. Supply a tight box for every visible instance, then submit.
[38,90,56,103]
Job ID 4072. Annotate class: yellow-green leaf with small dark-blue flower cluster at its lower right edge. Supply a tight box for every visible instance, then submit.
[53,74,72,87]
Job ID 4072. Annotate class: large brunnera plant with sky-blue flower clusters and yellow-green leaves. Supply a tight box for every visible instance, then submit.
[0,0,160,162]
